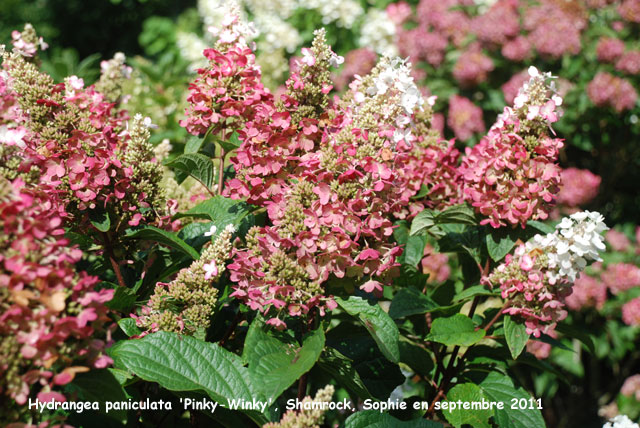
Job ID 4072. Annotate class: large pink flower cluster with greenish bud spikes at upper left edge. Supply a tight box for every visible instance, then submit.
[3,33,164,232]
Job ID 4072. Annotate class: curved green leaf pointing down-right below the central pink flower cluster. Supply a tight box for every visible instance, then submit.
[336,296,400,363]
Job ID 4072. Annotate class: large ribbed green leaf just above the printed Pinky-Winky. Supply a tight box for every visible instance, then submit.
[109,331,268,425]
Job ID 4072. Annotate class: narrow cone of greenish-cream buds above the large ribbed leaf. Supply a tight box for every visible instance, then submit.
[131,225,235,335]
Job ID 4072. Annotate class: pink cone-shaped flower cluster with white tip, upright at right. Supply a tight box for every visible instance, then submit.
[460,67,563,228]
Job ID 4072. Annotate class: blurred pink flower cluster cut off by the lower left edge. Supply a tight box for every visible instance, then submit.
[0,177,113,412]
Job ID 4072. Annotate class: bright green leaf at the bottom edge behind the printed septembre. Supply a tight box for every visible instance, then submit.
[441,383,492,428]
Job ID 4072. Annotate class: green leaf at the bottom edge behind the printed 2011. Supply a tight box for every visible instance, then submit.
[480,372,546,428]
